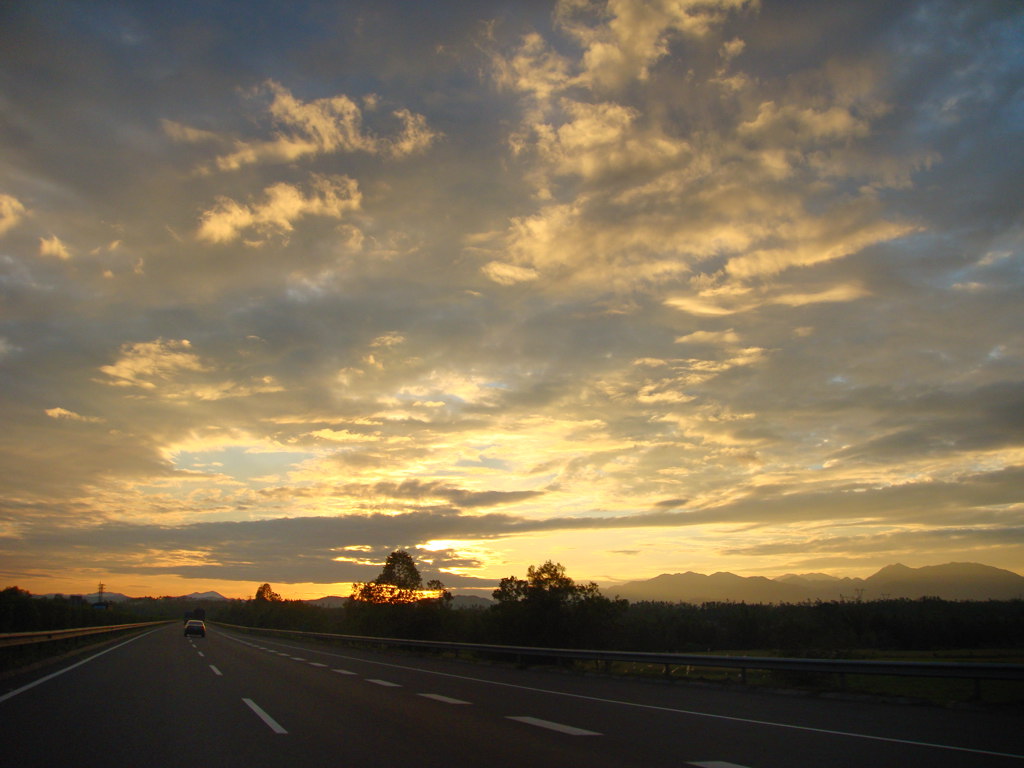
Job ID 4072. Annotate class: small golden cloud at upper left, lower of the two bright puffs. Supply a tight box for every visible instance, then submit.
[197,175,361,245]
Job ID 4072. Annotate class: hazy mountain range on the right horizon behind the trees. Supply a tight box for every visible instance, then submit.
[603,562,1024,603]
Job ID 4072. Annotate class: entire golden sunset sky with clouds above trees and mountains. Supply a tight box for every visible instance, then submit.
[0,0,1024,598]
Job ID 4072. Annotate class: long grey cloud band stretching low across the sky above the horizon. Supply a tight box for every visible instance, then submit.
[6,468,1024,586]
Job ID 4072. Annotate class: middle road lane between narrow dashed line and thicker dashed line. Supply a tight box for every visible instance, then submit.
[199,630,624,768]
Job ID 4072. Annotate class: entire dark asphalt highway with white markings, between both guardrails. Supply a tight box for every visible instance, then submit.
[0,625,1024,768]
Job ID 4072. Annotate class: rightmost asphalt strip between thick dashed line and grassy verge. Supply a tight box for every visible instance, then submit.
[209,636,1024,768]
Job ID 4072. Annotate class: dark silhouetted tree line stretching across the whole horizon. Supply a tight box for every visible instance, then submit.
[0,550,1024,655]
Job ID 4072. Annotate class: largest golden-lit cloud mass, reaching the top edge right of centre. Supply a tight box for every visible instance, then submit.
[484,1,923,301]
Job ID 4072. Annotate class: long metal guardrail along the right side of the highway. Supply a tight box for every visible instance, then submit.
[211,623,1024,685]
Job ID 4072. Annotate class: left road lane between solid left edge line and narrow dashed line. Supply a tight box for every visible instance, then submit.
[0,625,294,768]
